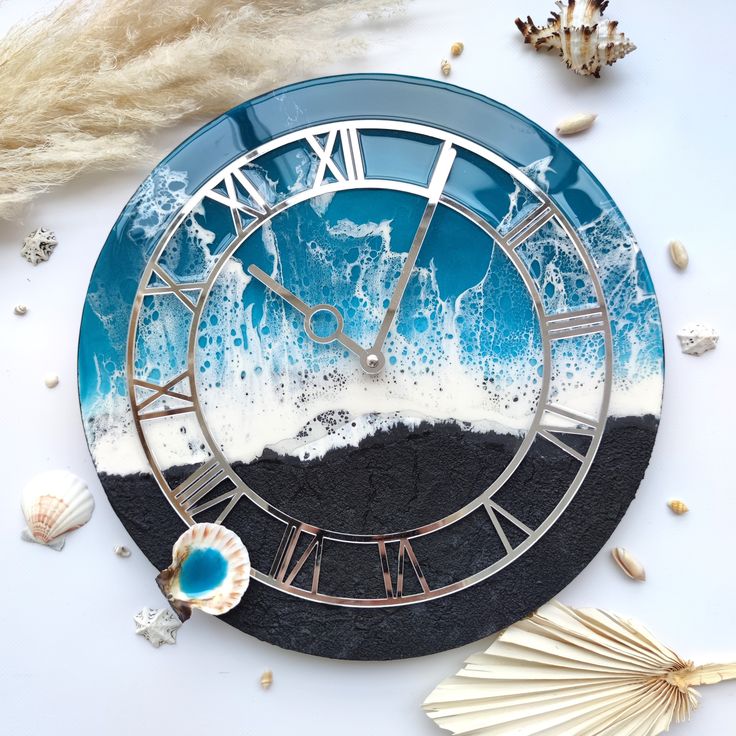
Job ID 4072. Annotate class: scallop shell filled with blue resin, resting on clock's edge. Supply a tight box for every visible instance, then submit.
[156,524,250,621]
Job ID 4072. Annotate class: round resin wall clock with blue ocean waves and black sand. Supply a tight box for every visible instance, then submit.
[79,75,663,659]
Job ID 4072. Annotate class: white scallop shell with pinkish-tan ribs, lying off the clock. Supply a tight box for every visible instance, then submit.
[21,470,95,550]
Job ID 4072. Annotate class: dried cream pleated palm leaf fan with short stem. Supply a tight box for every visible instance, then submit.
[424,602,736,736]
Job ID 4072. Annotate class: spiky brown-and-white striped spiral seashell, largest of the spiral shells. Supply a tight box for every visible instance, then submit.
[516,0,636,77]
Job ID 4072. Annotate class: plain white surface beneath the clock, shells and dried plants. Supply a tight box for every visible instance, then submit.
[0,0,736,736]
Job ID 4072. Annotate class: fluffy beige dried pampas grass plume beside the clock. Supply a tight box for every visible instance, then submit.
[0,0,401,219]
